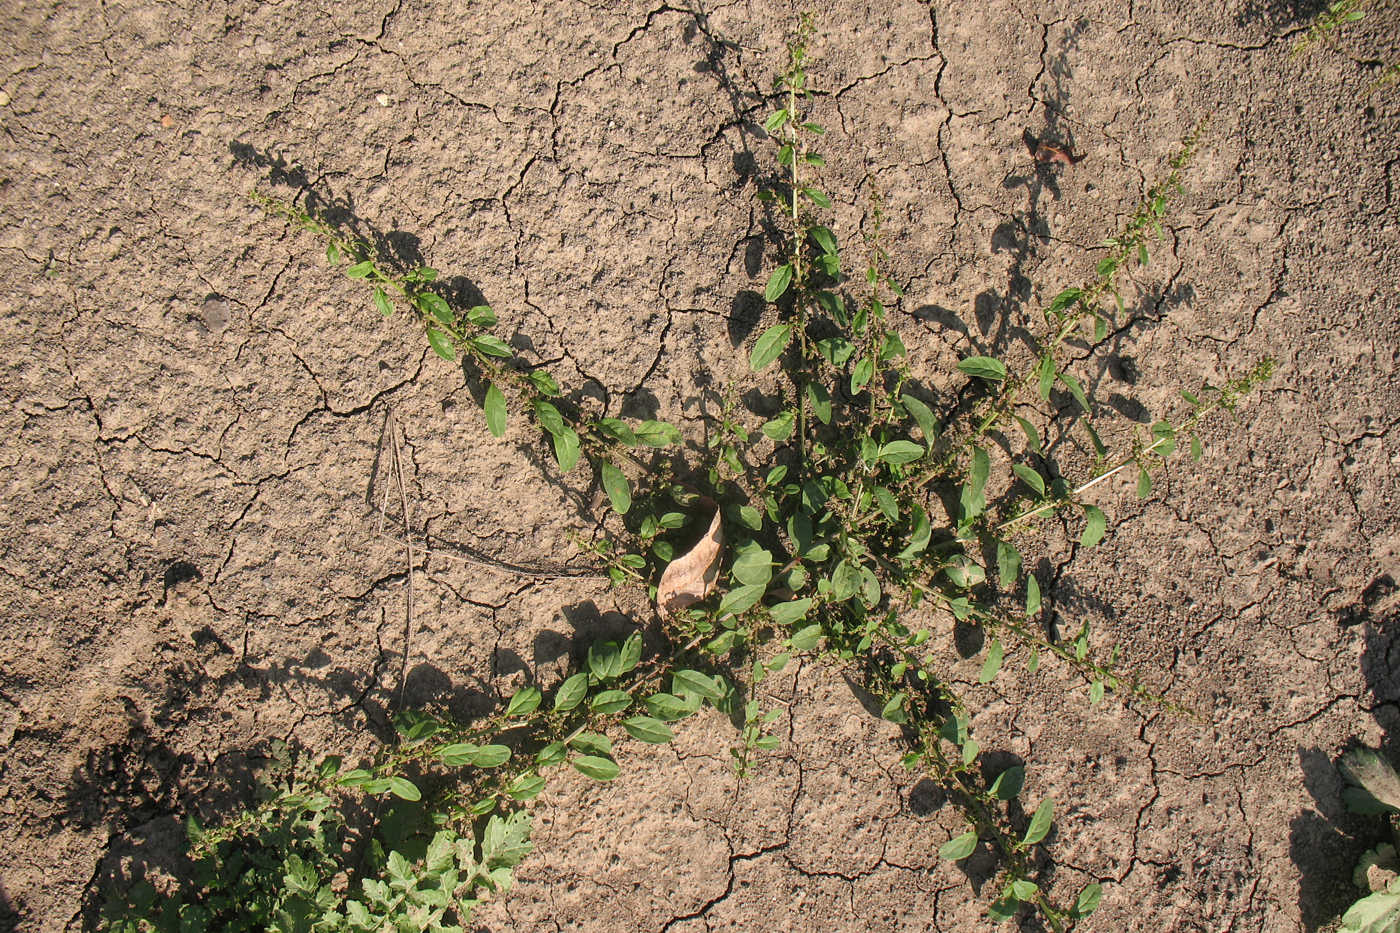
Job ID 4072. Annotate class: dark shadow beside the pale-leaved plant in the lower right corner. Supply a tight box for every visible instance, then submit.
[1288,576,1400,933]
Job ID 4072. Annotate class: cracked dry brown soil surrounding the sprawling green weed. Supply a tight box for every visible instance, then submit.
[0,0,1400,933]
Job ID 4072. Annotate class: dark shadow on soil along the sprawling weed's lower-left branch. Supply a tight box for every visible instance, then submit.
[73,562,732,933]
